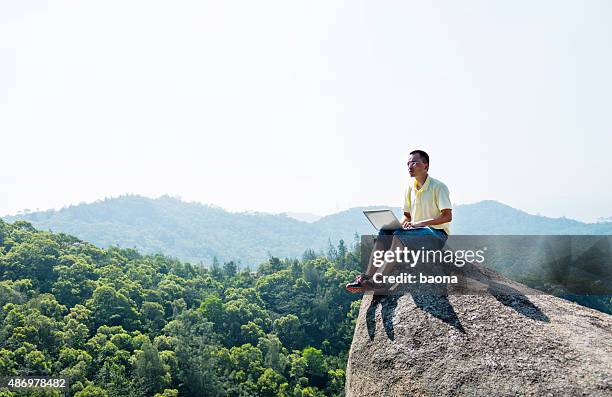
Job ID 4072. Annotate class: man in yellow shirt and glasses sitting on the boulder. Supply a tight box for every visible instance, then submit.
[346,150,453,293]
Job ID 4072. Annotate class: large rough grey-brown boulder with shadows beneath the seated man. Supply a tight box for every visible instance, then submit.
[346,264,612,397]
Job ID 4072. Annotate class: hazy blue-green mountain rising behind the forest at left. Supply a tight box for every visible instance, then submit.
[5,195,327,265]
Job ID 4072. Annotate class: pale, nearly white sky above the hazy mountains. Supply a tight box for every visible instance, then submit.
[0,0,612,221]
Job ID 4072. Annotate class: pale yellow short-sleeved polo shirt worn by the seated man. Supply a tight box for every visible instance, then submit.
[404,175,453,234]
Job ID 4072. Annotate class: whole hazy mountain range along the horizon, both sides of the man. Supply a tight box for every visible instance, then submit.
[5,196,612,266]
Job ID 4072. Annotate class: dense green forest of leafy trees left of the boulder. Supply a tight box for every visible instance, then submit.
[0,220,360,397]
